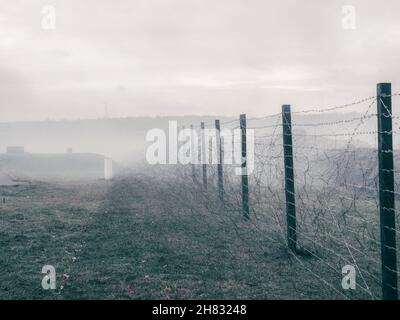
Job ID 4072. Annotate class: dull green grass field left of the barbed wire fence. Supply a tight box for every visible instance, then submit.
[0,175,382,299]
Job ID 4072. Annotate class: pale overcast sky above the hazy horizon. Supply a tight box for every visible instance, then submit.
[0,0,400,121]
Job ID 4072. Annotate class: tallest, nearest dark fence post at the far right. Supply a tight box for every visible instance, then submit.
[377,83,398,300]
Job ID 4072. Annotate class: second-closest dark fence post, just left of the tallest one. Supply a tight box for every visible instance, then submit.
[282,105,297,252]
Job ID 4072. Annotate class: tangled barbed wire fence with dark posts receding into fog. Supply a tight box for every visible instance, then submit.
[160,84,400,299]
